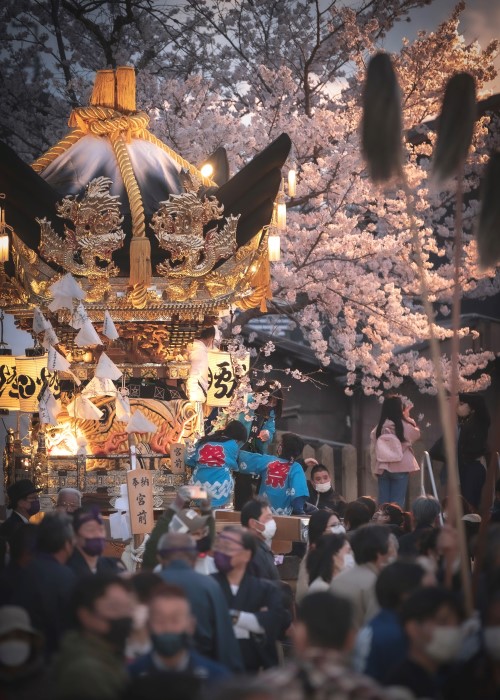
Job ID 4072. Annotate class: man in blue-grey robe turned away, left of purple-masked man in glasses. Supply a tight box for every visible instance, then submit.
[158,532,243,671]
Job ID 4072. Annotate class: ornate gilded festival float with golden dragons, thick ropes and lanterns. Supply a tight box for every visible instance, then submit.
[0,67,290,520]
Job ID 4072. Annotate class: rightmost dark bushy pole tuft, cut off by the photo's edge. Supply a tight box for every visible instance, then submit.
[476,151,500,268]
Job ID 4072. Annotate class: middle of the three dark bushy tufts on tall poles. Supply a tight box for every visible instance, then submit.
[433,73,477,182]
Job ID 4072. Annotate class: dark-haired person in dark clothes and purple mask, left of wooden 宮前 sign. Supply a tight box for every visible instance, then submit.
[67,506,124,577]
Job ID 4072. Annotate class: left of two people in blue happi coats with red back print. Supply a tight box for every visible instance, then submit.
[186,420,247,508]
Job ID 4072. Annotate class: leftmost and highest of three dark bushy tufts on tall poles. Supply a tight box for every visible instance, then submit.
[361,53,402,182]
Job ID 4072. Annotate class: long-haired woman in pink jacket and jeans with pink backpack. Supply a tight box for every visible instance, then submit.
[370,395,420,508]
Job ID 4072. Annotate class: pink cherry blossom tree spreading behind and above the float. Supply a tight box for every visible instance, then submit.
[0,0,500,394]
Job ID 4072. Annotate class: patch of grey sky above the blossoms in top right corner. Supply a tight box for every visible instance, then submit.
[384,0,500,92]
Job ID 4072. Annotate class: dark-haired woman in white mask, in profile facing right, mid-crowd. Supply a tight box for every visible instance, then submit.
[307,526,355,593]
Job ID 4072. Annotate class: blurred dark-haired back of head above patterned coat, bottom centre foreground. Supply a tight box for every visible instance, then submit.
[297,592,353,651]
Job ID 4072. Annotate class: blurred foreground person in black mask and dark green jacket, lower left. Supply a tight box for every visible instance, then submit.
[52,574,135,700]
